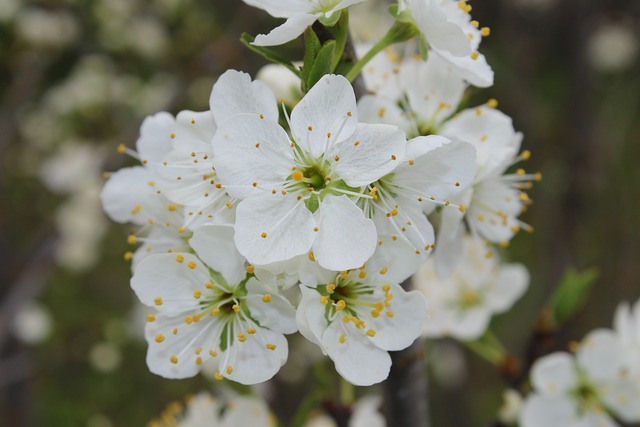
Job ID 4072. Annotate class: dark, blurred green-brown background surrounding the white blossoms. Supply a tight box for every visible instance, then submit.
[0,0,640,427]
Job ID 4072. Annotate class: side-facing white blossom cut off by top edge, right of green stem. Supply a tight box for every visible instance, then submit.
[401,0,493,87]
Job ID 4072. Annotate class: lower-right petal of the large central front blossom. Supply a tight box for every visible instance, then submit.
[313,195,376,271]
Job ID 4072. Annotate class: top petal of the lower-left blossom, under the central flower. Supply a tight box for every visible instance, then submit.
[189,225,246,285]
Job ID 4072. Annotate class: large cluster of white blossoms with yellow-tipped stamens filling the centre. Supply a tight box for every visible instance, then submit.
[101,0,534,385]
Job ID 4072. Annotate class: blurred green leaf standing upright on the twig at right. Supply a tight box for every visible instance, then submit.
[549,268,599,327]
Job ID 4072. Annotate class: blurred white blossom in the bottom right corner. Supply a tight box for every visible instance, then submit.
[520,330,640,427]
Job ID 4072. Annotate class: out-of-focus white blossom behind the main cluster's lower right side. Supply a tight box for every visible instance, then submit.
[413,238,529,340]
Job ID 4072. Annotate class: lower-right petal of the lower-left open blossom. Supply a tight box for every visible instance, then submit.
[216,328,289,385]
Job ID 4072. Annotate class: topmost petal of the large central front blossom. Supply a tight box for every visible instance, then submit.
[291,74,358,157]
